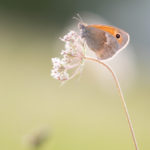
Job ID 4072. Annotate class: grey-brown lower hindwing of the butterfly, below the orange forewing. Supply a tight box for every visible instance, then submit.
[81,26,118,60]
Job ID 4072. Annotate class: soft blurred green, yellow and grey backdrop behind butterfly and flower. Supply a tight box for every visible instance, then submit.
[0,0,150,150]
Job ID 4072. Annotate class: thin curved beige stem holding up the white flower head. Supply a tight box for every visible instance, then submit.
[84,57,139,150]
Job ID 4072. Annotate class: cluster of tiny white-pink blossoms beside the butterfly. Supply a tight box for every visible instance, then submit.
[51,31,84,81]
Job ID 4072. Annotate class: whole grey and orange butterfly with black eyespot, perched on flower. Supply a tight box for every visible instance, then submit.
[79,23,129,60]
